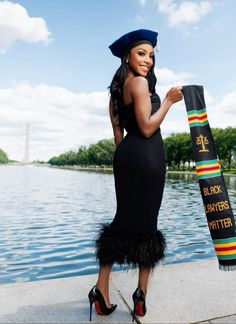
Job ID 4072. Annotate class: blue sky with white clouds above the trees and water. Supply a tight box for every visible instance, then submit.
[0,0,236,161]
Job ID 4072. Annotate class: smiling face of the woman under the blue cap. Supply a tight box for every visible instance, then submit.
[127,44,154,77]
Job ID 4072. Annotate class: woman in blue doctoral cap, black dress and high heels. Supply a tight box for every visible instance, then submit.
[89,29,182,320]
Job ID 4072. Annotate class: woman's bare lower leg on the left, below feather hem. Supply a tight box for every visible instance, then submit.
[96,264,112,307]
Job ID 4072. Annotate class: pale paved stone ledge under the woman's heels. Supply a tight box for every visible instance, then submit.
[0,259,236,324]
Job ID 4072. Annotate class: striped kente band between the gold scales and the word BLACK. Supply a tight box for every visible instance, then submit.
[196,159,221,179]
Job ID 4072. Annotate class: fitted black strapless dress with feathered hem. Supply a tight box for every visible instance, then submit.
[96,94,166,268]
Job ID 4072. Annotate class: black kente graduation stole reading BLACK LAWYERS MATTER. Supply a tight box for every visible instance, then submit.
[183,85,236,270]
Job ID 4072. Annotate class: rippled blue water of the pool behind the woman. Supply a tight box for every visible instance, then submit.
[0,166,236,284]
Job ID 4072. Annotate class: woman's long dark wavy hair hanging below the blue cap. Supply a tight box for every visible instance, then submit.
[108,55,157,123]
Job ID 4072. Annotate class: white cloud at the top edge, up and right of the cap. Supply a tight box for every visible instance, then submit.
[158,0,213,27]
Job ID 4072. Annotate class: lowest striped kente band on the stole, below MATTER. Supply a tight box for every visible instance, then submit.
[213,237,236,260]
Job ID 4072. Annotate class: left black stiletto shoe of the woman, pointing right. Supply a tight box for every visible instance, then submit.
[88,286,117,322]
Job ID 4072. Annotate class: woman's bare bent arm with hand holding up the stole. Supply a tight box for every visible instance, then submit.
[129,76,183,138]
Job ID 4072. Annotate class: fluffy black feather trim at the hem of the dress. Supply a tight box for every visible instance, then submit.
[95,224,166,269]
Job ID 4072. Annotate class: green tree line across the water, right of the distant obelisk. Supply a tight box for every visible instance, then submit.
[48,127,236,170]
